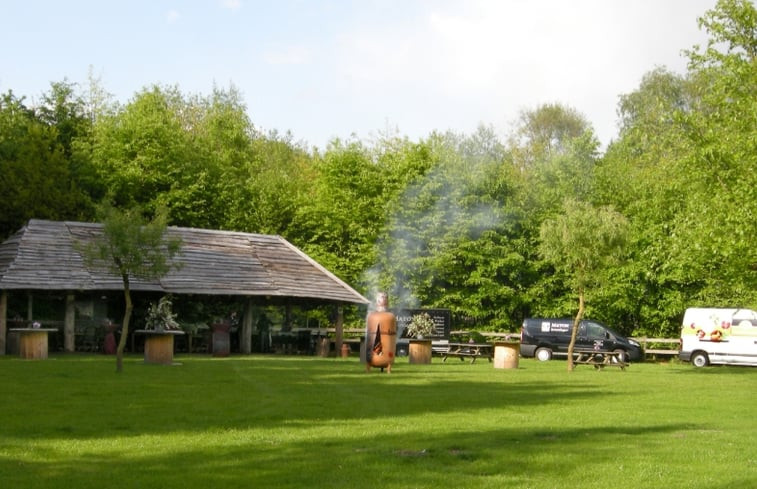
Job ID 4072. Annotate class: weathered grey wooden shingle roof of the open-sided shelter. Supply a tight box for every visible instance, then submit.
[0,219,369,304]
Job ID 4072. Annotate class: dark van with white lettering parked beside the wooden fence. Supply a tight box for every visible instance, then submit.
[520,318,643,362]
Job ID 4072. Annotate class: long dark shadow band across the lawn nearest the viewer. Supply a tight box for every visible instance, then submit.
[1,416,696,489]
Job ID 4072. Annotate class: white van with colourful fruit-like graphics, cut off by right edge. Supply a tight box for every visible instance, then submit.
[678,307,757,367]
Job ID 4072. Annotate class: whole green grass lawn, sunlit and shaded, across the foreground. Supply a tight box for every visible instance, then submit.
[0,355,757,489]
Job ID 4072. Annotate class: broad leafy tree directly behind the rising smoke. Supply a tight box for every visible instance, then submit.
[376,127,527,329]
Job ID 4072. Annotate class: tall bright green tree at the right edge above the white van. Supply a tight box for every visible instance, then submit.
[675,0,757,305]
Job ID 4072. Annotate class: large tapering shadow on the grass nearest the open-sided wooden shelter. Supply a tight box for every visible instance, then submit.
[0,356,614,439]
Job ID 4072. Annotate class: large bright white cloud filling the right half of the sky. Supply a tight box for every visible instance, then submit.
[326,0,704,143]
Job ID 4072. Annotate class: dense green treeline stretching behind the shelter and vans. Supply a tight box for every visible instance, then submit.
[0,0,757,336]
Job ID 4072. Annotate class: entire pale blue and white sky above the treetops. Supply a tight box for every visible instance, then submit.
[0,0,715,149]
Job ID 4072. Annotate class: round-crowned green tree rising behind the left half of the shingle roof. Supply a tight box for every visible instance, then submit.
[85,86,227,227]
